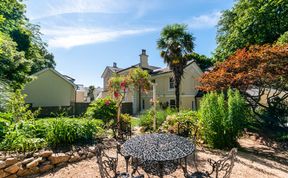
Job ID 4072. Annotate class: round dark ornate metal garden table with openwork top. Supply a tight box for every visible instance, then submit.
[121,133,195,177]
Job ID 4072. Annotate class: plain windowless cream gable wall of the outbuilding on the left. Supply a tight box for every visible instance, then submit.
[23,70,75,107]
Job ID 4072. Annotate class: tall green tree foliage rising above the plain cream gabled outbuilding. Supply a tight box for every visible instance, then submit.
[0,0,55,89]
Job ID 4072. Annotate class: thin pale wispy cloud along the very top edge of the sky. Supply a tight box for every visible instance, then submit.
[28,0,153,20]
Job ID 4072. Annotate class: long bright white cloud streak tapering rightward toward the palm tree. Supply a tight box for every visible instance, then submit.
[42,27,155,48]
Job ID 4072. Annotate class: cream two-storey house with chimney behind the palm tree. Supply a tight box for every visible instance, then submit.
[102,50,203,114]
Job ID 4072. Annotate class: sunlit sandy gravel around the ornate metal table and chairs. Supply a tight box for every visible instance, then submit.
[32,143,288,178]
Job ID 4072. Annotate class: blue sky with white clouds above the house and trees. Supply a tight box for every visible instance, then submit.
[24,0,234,86]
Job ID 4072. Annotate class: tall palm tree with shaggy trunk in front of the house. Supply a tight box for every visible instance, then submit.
[157,24,194,111]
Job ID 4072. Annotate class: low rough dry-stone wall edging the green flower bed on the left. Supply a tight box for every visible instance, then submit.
[0,146,96,178]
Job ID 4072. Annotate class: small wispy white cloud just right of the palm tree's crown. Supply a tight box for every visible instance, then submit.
[186,12,221,29]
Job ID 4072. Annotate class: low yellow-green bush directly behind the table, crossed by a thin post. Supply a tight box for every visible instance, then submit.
[139,108,175,131]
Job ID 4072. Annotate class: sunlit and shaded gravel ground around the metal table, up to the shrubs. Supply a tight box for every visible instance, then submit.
[32,135,288,178]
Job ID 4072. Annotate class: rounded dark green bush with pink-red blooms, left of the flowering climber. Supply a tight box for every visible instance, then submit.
[85,98,117,123]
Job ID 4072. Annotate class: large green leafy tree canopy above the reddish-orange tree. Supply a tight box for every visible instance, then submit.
[214,0,288,61]
